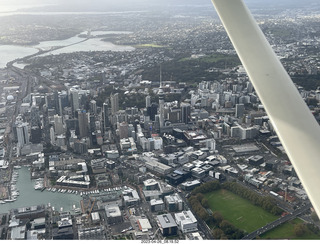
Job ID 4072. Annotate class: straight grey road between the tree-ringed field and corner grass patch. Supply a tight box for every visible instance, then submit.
[242,204,312,240]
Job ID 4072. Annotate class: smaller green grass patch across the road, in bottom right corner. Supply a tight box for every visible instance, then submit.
[260,219,320,240]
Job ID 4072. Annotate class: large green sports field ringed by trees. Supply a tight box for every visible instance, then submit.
[205,189,278,233]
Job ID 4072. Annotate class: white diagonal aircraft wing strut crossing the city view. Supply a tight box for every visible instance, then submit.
[212,0,320,216]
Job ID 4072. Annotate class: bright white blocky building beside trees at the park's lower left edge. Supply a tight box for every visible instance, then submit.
[174,210,198,233]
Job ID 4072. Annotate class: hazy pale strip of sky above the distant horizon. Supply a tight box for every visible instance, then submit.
[0,0,320,12]
